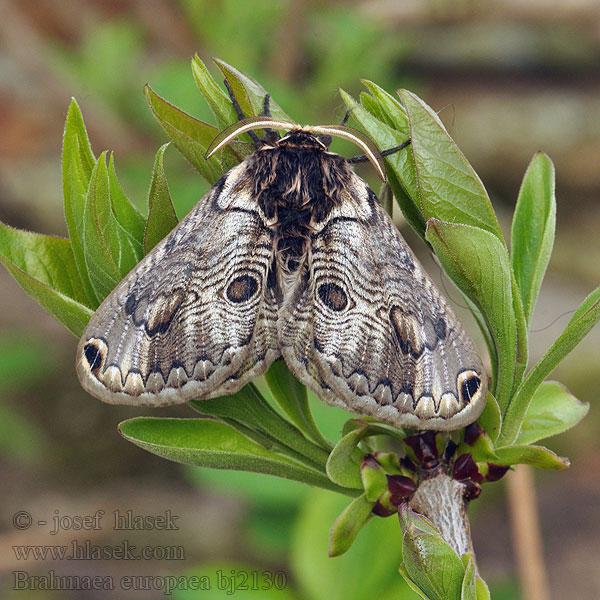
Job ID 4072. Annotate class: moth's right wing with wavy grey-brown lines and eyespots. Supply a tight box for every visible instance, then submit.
[278,174,487,430]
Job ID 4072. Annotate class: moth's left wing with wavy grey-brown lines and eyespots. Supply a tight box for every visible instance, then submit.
[77,164,279,406]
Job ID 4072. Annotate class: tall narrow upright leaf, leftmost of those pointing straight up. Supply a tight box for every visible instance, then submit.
[62,98,100,306]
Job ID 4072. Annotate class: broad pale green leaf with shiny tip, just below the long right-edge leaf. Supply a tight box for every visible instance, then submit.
[516,381,590,444]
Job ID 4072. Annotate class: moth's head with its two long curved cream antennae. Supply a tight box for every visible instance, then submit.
[205,117,385,181]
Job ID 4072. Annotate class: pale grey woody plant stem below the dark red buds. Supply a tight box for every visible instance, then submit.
[410,465,475,556]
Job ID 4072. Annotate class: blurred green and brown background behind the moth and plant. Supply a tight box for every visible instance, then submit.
[0,0,600,600]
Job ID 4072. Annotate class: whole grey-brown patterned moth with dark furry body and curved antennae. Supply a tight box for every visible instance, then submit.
[77,116,487,430]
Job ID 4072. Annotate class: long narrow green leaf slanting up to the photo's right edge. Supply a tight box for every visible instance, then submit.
[498,287,600,446]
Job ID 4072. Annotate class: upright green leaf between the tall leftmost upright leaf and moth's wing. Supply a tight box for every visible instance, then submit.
[82,152,143,301]
